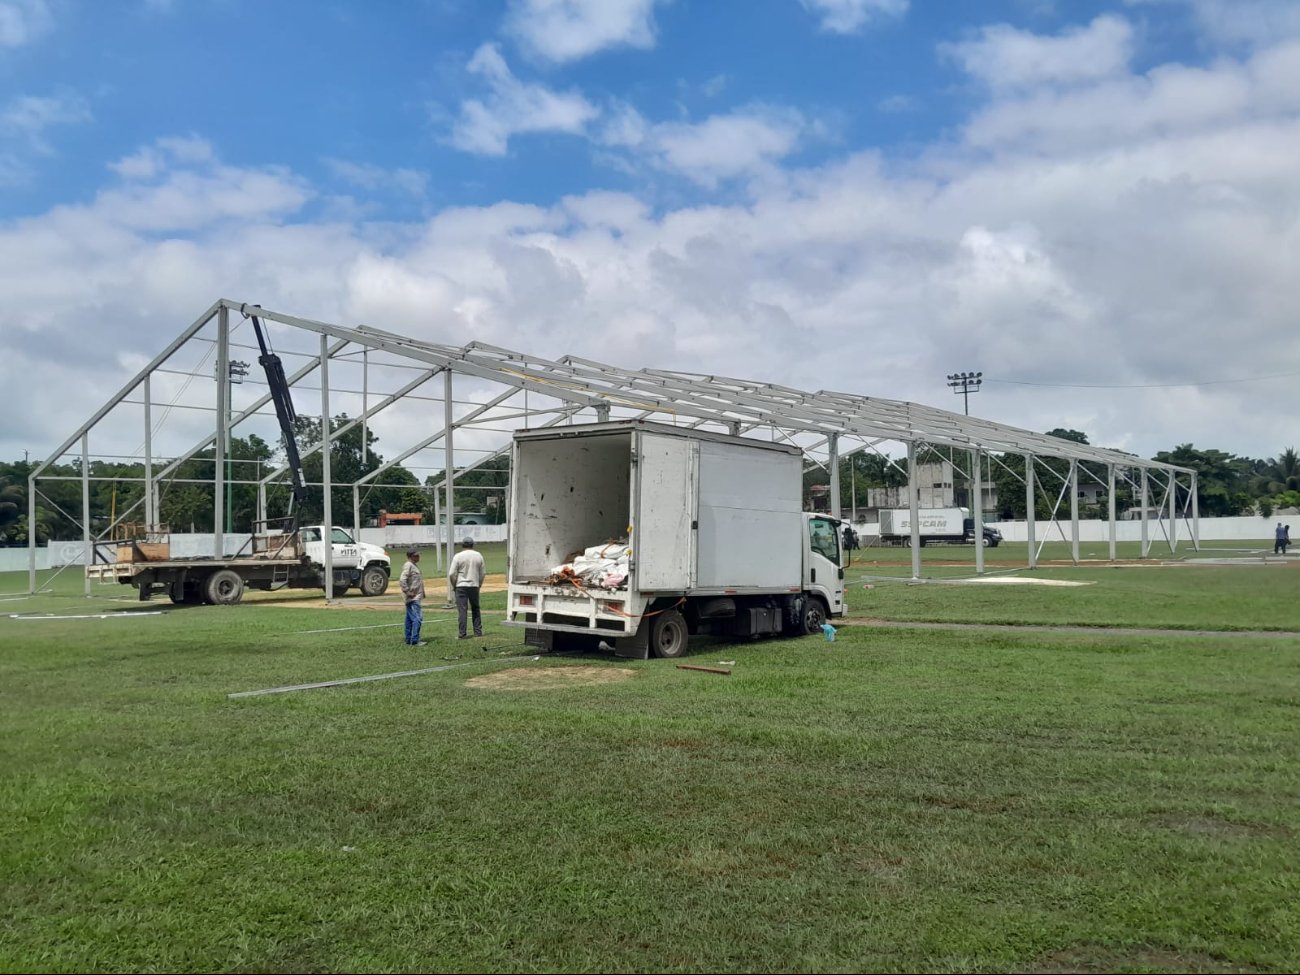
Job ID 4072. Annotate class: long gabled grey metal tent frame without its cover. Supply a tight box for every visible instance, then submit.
[27,299,1200,599]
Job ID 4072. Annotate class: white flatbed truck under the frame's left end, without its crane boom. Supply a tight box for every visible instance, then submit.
[86,525,393,605]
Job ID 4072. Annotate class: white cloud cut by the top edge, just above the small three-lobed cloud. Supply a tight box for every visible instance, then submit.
[506,0,663,61]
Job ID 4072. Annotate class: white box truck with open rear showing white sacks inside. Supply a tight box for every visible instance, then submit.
[507,420,844,659]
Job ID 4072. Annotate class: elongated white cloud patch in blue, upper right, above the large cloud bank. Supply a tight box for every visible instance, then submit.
[940,16,1134,88]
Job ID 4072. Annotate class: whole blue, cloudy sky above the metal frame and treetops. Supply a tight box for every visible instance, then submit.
[0,0,1300,470]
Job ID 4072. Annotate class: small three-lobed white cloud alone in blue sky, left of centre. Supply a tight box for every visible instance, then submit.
[451,44,599,156]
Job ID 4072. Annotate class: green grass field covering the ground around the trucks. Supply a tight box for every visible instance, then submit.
[0,546,1300,972]
